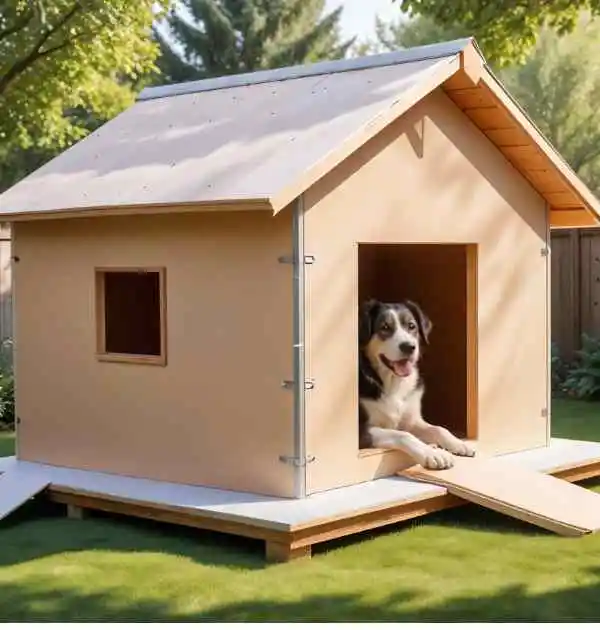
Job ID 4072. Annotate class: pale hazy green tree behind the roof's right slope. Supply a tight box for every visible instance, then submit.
[370,15,600,194]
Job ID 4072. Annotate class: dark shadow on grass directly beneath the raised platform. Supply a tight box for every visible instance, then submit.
[0,488,554,570]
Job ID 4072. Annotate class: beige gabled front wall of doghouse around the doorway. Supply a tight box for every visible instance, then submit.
[305,86,547,491]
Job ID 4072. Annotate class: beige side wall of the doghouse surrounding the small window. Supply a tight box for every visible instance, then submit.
[15,212,293,496]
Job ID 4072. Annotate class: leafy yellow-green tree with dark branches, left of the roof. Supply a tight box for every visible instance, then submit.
[0,0,167,152]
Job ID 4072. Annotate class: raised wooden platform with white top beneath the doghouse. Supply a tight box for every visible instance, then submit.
[0,439,600,561]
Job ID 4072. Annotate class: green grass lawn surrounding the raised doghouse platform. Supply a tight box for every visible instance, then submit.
[0,401,600,621]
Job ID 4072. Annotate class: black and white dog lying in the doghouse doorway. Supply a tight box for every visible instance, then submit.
[358,300,475,469]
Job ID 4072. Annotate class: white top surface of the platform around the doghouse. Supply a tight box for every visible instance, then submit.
[0,439,600,531]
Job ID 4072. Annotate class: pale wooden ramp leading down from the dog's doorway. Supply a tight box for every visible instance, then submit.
[398,457,600,536]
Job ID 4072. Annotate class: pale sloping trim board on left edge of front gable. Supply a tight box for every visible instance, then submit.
[270,53,463,214]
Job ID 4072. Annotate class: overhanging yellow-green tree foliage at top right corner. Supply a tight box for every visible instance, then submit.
[392,0,600,67]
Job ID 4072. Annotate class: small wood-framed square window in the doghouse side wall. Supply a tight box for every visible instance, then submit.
[96,269,166,365]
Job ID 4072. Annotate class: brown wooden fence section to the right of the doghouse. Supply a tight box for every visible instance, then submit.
[551,228,600,361]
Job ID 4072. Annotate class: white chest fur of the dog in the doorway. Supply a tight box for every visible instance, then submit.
[361,370,423,431]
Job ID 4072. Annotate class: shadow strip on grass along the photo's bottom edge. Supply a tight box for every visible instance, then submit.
[0,574,600,622]
